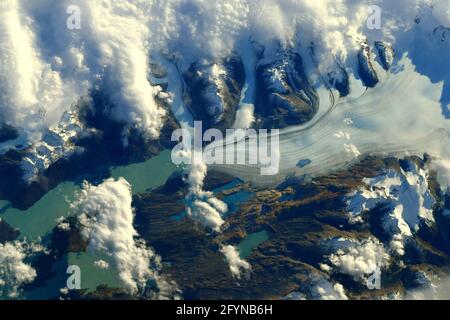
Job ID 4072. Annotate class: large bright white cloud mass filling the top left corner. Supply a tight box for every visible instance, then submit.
[0,0,165,150]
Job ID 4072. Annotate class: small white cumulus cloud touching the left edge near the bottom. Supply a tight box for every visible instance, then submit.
[0,241,42,298]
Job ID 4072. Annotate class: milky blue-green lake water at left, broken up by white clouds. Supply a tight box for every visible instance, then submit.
[0,150,180,299]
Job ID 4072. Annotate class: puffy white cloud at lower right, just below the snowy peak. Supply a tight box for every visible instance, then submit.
[322,238,390,281]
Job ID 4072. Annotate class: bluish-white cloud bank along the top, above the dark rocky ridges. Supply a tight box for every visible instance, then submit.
[147,0,449,79]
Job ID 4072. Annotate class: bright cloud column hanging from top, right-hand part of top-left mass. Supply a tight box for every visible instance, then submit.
[79,1,165,139]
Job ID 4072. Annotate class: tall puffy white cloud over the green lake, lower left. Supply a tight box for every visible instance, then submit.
[71,178,176,298]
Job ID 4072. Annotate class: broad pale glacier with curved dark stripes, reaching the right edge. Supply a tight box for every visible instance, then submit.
[209,55,450,184]
